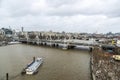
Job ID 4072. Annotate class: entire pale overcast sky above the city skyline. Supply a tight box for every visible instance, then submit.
[0,0,120,33]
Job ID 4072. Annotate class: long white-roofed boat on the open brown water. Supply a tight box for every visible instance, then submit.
[21,58,43,75]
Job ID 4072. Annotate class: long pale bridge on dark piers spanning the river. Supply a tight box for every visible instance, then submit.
[19,32,99,49]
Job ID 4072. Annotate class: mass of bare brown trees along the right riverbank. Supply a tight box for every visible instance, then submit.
[90,48,120,80]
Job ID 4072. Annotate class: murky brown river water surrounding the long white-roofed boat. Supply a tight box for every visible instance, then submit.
[0,44,90,80]
